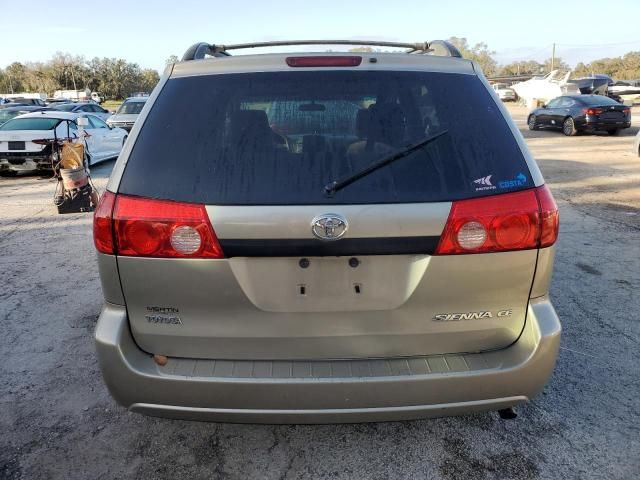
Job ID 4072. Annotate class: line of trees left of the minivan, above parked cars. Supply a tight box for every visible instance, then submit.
[0,52,160,100]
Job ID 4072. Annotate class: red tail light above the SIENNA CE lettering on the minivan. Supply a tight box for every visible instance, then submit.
[435,185,559,255]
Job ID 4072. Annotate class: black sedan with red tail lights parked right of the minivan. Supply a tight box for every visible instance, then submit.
[527,95,631,136]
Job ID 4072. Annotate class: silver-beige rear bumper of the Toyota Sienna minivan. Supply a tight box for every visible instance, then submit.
[95,298,561,423]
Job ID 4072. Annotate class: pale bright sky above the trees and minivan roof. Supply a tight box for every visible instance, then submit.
[0,0,640,71]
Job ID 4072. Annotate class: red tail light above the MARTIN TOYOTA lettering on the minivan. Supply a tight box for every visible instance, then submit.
[94,192,224,258]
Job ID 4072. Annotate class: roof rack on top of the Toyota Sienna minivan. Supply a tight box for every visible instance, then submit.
[182,40,462,62]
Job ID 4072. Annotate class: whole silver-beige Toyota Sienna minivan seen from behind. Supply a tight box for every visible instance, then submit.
[94,41,561,423]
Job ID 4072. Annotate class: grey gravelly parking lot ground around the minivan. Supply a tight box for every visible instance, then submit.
[0,106,640,479]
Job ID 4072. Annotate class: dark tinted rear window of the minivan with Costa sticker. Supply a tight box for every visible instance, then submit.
[120,70,533,205]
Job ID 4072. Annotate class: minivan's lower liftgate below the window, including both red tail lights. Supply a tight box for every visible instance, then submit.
[95,186,558,359]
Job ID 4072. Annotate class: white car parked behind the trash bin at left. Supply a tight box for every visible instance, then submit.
[0,110,127,174]
